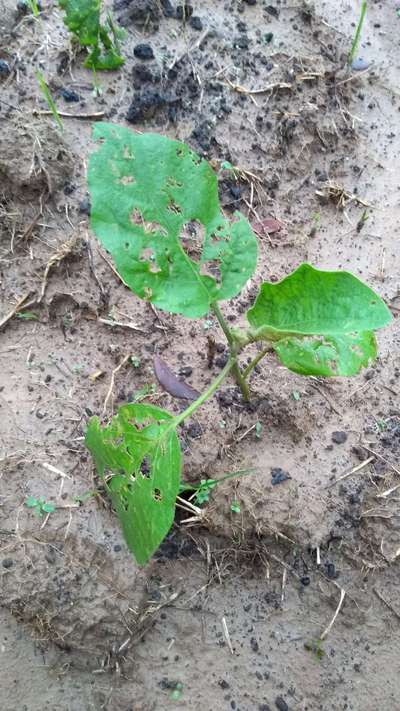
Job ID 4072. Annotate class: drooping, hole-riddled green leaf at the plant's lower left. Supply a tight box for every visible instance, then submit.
[85,403,181,564]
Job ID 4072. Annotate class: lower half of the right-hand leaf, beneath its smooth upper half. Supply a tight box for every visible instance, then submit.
[272,331,377,378]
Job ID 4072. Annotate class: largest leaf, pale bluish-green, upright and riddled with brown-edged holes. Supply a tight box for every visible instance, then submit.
[88,123,257,318]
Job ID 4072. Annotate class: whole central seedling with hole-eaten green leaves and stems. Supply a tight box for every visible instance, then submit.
[86,123,392,563]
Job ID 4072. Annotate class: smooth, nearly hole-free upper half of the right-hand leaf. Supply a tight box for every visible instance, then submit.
[247,264,392,340]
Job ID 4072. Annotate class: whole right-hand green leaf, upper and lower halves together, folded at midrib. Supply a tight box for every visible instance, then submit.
[247,264,392,376]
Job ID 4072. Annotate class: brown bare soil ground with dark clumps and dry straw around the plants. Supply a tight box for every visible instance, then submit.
[0,0,400,711]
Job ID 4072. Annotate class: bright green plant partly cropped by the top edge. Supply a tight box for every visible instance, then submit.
[59,0,125,71]
